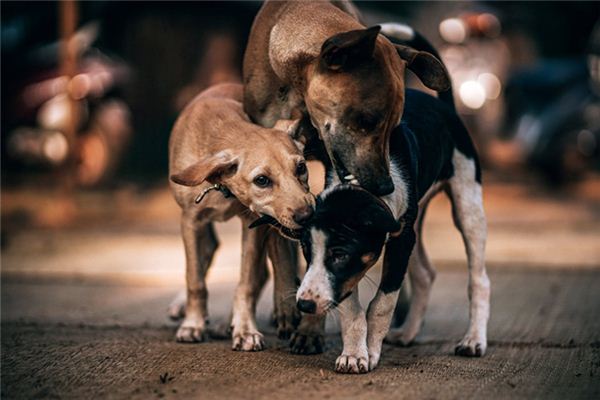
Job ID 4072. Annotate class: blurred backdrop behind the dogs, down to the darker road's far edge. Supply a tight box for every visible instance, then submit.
[1,1,600,313]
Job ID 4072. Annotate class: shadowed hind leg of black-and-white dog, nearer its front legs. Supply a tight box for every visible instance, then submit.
[386,204,435,346]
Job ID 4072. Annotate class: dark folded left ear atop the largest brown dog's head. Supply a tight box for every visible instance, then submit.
[320,25,381,71]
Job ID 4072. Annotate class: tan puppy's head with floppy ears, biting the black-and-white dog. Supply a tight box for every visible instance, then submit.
[171,121,315,229]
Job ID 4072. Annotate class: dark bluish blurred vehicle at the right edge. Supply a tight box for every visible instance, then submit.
[505,25,600,184]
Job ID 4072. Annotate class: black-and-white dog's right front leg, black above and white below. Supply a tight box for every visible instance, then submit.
[367,224,415,370]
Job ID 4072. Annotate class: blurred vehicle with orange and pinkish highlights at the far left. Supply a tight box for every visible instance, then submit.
[6,23,132,186]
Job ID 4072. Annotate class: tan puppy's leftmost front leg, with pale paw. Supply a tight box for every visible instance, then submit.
[175,217,219,342]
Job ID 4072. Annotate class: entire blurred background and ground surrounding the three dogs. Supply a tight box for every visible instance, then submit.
[0,1,600,399]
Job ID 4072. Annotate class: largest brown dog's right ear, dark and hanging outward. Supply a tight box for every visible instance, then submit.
[394,44,451,92]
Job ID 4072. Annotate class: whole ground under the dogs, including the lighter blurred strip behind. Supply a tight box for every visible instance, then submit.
[1,185,600,400]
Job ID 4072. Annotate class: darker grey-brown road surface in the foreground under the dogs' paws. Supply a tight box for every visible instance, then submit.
[2,268,600,399]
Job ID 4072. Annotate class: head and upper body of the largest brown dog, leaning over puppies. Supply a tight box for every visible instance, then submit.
[244,1,450,196]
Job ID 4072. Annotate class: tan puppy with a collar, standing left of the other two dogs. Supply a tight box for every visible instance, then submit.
[169,84,314,351]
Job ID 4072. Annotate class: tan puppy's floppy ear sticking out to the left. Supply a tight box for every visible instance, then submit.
[171,153,238,186]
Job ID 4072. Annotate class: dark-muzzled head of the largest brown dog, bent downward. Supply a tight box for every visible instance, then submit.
[305,26,450,196]
